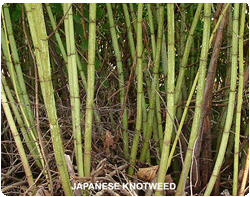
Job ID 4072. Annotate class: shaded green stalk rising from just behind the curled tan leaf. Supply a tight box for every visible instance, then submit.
[140,3,164,161]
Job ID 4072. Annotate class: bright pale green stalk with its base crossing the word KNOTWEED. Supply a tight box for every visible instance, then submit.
[155,3,175,196]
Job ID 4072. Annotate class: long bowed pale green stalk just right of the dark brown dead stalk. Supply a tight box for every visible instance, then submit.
[204,3,239,196]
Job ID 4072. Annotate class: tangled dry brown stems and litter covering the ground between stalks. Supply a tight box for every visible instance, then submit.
[1,88,248,196]
